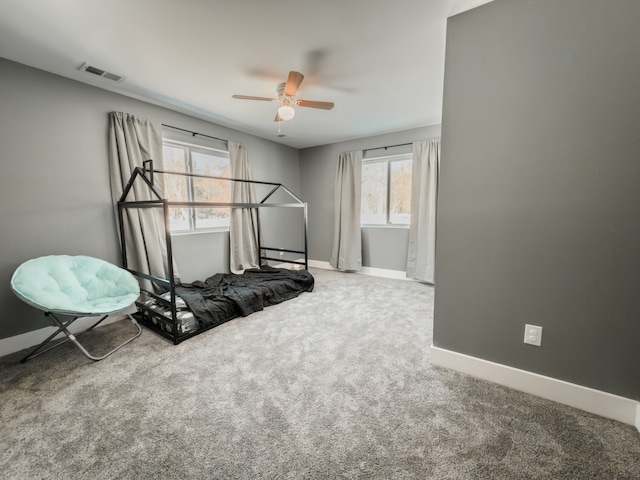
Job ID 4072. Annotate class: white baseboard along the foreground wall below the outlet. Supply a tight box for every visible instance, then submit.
[431,345,640,431]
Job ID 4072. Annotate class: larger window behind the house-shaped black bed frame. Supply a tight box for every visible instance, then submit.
[162,139,231,233]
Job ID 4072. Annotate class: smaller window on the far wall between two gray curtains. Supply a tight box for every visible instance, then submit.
[360,154,412,225]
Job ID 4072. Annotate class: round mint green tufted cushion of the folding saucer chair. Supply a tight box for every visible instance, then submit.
[11,255,140,316]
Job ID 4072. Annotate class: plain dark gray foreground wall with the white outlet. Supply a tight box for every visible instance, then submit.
[434,0,640,400]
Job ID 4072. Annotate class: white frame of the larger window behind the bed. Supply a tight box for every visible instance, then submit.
[162,137,231,235]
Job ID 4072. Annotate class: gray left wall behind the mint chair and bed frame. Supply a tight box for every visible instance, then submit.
[0,59,302,338]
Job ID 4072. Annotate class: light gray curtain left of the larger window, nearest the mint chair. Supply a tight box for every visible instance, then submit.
[109,112,177,290]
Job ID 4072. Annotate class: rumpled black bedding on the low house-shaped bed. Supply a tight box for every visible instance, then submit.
[176,266,314,328]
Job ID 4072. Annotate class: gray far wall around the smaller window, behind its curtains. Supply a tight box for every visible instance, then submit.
[300,125,440,271]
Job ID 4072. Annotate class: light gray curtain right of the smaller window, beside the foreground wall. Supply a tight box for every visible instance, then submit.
[407,138,440,283]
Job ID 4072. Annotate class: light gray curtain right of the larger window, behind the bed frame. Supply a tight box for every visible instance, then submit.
[229,142,260,273]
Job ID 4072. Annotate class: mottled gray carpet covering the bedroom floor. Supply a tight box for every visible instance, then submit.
[0,269,640,480]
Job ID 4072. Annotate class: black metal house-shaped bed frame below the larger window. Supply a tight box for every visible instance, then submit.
[118,160,308,345]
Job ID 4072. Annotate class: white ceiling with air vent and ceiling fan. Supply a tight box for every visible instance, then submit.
[0,0,490,148]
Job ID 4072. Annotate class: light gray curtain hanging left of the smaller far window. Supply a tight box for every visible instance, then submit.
[329,150,362,271]
